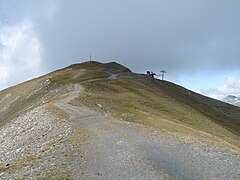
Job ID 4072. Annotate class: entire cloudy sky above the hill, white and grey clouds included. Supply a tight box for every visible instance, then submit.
[0,0,240,99]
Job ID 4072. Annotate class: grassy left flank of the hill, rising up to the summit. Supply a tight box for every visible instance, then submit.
[0,62,129,127]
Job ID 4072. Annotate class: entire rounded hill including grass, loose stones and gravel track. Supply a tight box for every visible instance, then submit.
[0,62,240,179]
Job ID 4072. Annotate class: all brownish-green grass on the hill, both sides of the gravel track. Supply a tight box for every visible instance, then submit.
[0,62,240,147]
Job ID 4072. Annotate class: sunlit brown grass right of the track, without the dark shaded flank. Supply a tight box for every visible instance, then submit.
[73,77,240,147]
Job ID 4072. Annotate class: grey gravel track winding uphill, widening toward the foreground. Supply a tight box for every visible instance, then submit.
[56,85,240,179]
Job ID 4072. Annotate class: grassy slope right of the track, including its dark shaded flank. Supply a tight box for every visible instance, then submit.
[66,61,240,147]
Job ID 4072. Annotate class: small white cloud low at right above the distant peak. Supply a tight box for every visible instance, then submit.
[201,77,240,99]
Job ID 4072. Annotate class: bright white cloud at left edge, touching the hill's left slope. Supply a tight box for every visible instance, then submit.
[0,21,41,89]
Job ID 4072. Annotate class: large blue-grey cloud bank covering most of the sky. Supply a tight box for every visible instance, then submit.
[0,0,240,74]
